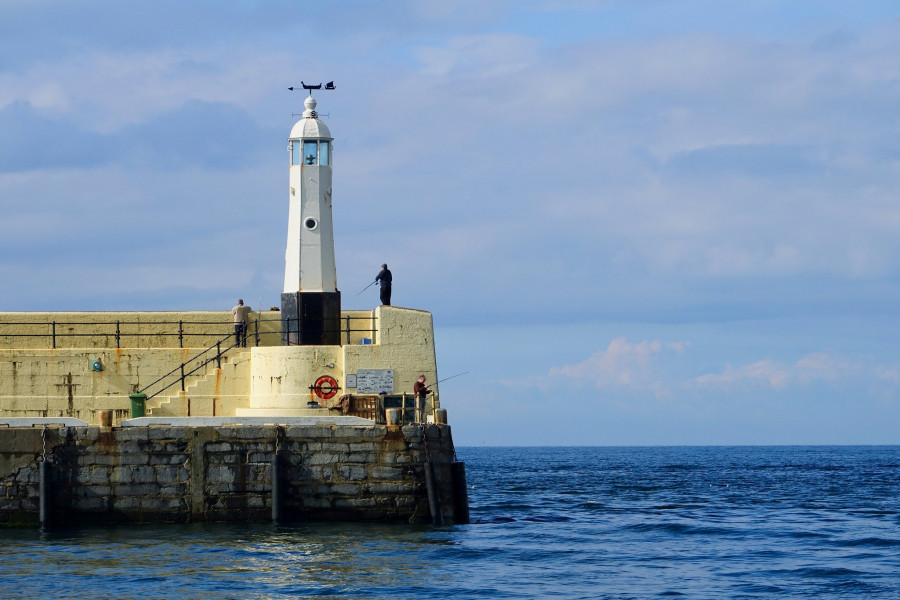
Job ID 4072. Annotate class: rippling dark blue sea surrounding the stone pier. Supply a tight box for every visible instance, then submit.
[0,446,900,600]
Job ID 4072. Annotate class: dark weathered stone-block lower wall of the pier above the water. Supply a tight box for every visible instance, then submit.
[0,424,458,527]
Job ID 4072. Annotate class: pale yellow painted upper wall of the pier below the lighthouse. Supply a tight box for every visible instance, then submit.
[0,306,440,425]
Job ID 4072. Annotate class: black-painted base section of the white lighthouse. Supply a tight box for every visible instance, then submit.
[281,292,341,346]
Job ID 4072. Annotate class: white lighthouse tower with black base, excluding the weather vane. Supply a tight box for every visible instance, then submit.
[281,96,341,345]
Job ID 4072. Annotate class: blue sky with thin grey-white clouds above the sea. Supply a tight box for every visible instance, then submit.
[0,0,900,445]
